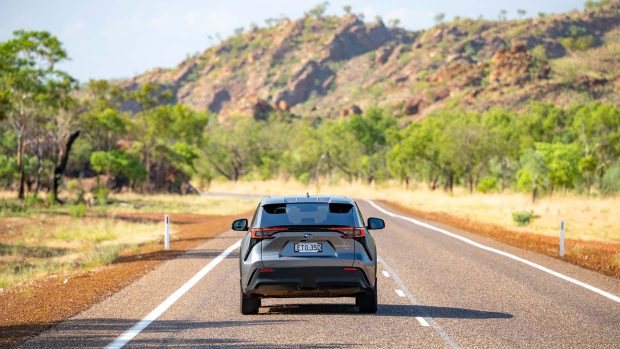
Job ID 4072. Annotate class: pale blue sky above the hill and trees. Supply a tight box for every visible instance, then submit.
[0,0,584,82]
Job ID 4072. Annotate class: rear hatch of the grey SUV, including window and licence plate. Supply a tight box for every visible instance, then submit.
[253,202,363,268]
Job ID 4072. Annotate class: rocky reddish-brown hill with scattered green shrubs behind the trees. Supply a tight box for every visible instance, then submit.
[126,0,620,120]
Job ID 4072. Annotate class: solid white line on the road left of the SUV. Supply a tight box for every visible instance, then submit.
[106,240,241,349]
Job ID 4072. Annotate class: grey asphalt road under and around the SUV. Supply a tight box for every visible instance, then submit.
[22,201,620,348]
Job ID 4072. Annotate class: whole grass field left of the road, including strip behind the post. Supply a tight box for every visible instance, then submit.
[0,192,257,289]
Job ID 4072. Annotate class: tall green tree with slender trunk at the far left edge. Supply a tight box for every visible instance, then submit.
[0,30,75,199]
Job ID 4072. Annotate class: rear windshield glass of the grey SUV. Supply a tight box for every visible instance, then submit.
[260,203,358,228]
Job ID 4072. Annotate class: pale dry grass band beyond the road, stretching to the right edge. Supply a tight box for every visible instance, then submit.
[209,180,620,242]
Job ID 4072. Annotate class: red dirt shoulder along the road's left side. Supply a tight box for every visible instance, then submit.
[0,213,247,348]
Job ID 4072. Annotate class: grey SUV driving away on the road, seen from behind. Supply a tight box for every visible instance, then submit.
[232,196,385,314]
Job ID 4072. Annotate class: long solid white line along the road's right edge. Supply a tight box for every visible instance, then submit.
[366,200,620,303]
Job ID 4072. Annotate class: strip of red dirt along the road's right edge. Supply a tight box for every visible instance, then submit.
[381,201,620,279]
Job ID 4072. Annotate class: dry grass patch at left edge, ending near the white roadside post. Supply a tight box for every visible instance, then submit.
[0,217,161,288]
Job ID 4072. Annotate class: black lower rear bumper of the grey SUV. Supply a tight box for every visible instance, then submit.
[243,267,374,298]
